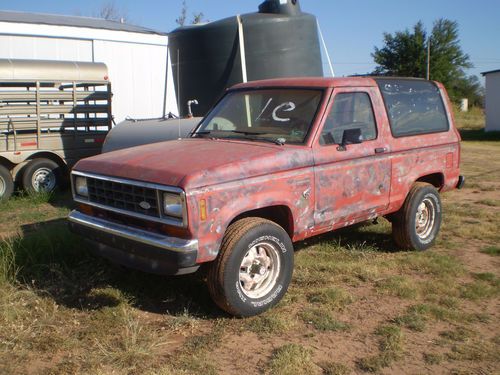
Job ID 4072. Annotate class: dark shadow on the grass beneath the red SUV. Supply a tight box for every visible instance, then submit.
[10,219,395,320]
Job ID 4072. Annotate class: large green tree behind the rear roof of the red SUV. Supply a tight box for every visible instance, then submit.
[372,18,481,104]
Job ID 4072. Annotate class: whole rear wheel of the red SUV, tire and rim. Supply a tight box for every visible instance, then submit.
[392,182,442,251]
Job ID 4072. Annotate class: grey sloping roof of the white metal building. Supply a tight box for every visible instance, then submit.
[0,11,167,35]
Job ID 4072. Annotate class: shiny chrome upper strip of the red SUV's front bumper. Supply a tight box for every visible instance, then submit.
[68,210,198,252]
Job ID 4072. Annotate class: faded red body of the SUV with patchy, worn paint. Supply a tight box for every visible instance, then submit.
[70,78,460,274]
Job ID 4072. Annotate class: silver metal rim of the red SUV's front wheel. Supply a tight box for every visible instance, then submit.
[239,242,281,299]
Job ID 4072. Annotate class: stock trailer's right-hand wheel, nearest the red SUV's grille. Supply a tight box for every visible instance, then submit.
[22,158,62,193]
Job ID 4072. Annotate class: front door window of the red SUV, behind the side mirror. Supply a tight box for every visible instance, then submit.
[320,92,377,145]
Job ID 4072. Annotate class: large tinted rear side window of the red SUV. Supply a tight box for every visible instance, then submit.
[377,79,449,137]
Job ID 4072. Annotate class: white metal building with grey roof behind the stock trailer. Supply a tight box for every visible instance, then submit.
[0,11,177,123]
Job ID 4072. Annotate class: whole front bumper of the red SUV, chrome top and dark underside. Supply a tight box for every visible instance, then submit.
[68,210,199,275]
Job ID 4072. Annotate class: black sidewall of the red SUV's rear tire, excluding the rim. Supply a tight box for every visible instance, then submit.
[406,186,443,251]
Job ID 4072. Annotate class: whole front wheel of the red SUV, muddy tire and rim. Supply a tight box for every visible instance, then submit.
[207,218,293,317]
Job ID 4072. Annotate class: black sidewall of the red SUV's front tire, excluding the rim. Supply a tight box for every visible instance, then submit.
[223,224,293,316]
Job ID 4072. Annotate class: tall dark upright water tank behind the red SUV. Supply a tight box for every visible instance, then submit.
[169,0,323,116]
